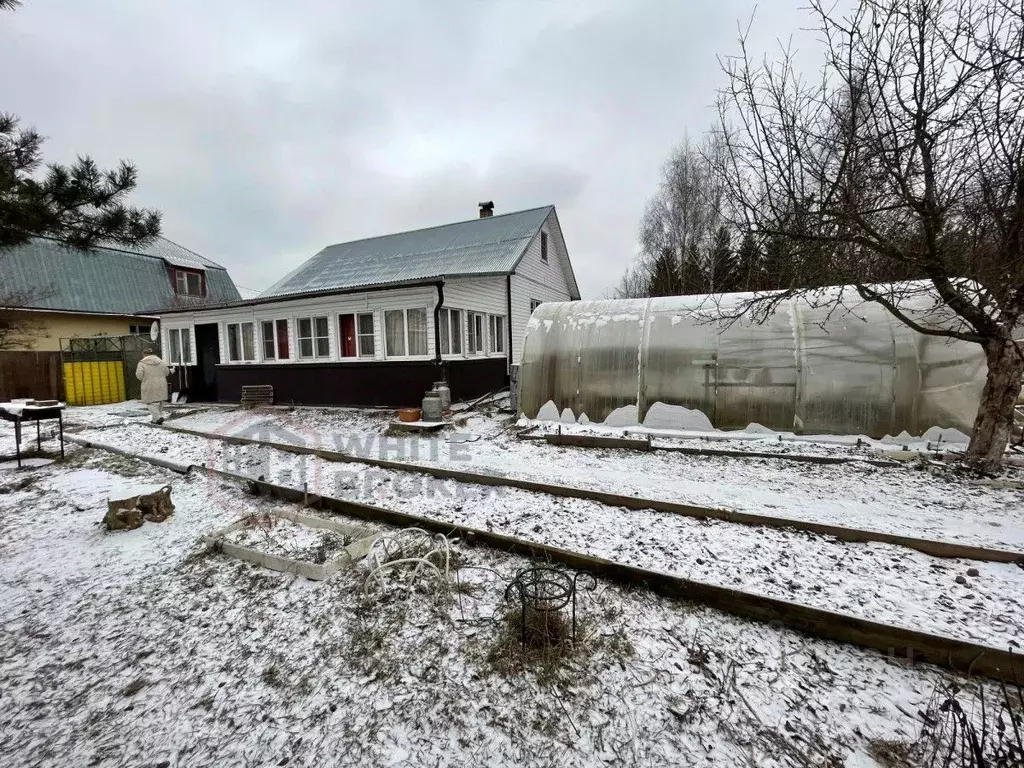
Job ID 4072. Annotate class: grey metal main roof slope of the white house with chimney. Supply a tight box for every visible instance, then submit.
[260,206,554,298]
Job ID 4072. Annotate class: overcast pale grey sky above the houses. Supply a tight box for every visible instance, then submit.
[0,0,807,298]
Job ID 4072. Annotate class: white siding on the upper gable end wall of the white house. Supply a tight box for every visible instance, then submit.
[511,208,572,365]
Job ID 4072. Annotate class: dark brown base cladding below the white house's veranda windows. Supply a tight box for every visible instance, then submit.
[217,357,508,408]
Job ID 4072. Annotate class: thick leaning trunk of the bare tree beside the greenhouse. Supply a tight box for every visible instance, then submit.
[967,340,1024,472]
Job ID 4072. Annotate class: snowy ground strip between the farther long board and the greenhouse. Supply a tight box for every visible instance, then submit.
[144,408,1024,552]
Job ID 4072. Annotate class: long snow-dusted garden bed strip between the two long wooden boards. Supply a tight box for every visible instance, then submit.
[72,425,1024,649]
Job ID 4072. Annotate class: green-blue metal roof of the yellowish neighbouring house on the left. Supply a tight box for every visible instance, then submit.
[0,238,241,314]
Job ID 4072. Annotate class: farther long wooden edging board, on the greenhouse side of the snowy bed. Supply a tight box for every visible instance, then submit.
[145,424,1024,563]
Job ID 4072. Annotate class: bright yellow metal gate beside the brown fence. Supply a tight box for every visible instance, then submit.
[60,335,158,406]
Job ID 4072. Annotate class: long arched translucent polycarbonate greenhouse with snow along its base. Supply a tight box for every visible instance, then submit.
[519,294,985,437]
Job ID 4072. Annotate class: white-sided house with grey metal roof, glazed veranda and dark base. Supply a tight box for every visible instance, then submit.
[158,205,580,406]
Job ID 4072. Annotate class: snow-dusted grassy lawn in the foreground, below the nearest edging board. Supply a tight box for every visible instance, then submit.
[0,442,1007,768]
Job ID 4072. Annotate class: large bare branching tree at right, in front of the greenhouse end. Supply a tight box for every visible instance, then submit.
[718,0,1024,470]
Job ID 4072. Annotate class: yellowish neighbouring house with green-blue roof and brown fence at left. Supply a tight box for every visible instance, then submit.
[0,238,241,399]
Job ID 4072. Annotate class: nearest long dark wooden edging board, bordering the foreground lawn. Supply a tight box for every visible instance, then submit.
[59,439,1024,682]
